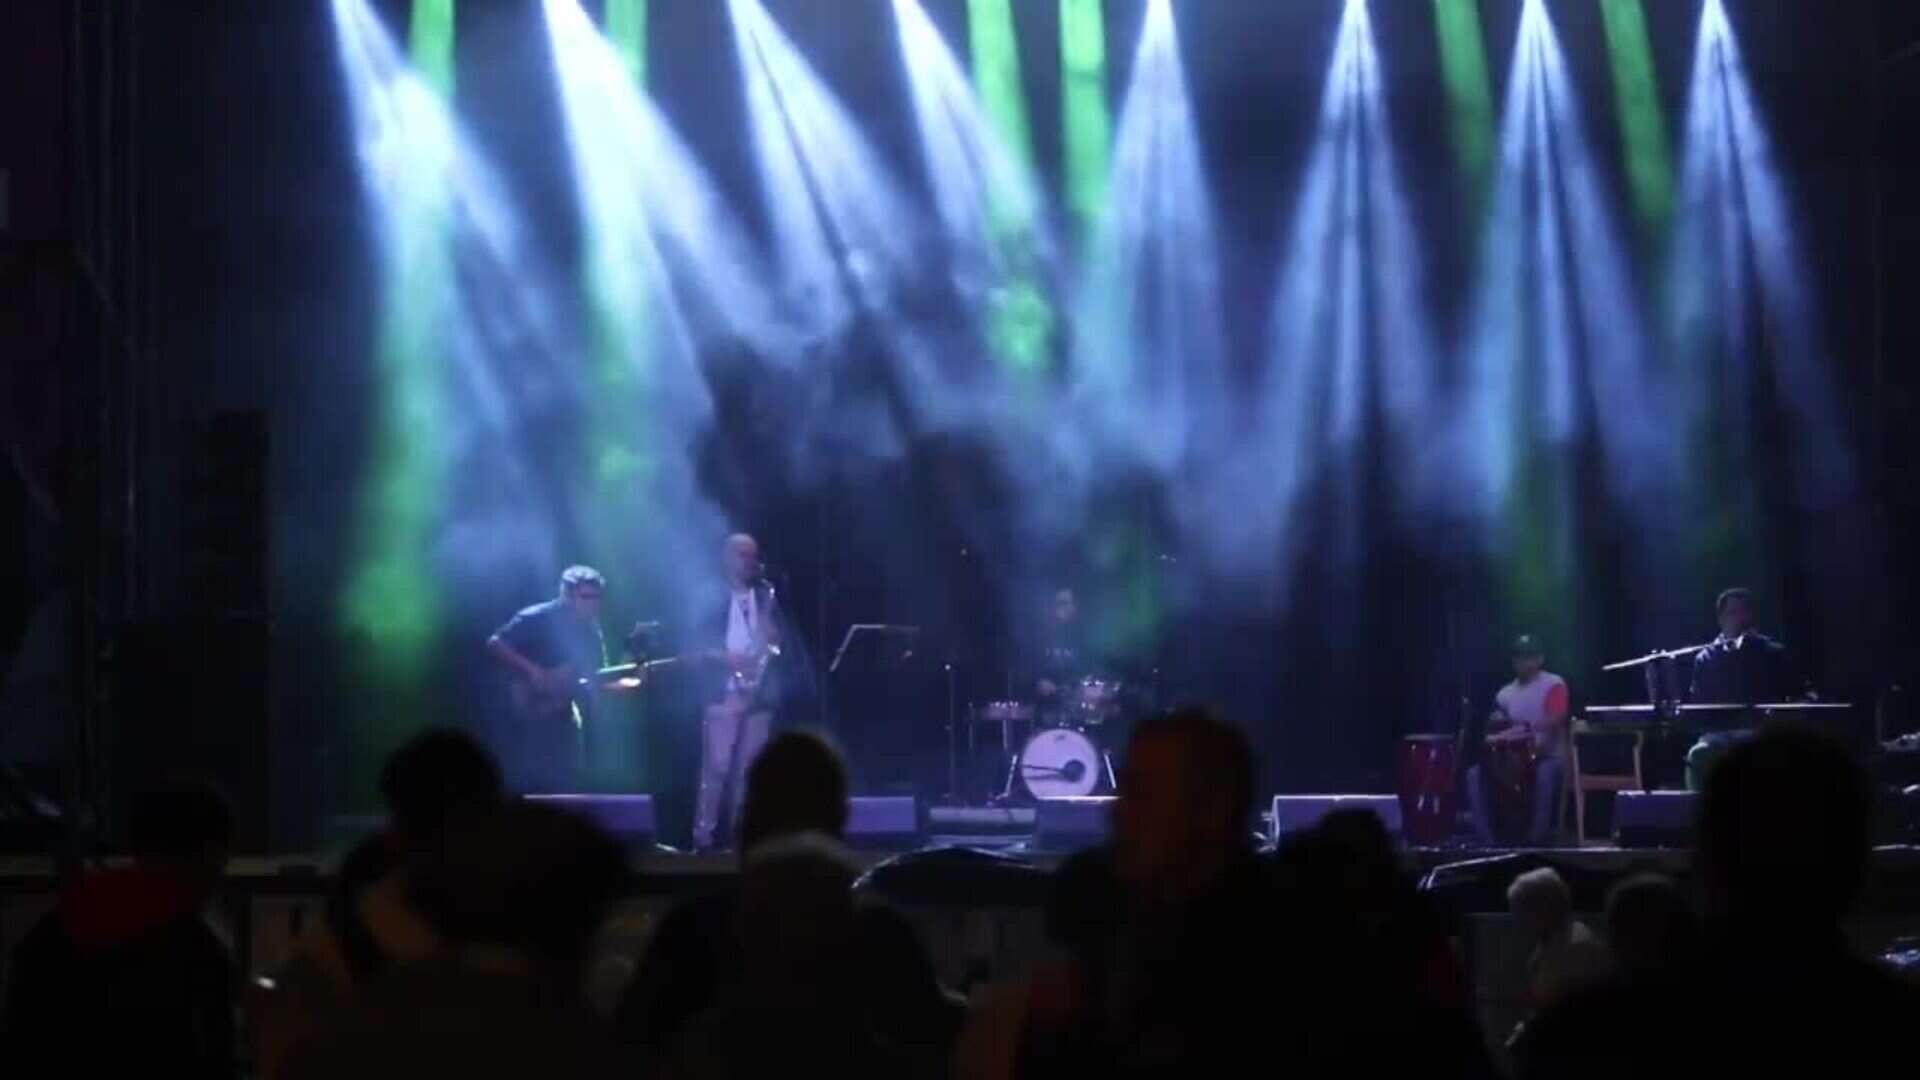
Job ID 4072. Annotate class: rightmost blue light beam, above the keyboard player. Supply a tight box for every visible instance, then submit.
[1668,0,1864,580]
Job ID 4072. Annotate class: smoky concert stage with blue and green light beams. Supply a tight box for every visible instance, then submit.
[0,0,1920,941]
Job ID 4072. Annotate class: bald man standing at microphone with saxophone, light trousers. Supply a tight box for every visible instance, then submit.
[693,532,781,851]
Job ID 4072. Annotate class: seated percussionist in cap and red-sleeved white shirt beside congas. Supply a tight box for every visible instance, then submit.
[1467,634,1569,847]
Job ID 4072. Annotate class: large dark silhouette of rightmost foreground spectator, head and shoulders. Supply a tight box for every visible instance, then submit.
[1515,728,1920,1078]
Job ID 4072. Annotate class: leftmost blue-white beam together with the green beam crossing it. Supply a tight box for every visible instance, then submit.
[332,0,566,687]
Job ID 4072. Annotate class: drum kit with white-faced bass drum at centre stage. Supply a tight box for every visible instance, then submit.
[973,676,1125,799]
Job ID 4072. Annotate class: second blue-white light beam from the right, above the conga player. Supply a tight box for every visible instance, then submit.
[1461,0,1672,663]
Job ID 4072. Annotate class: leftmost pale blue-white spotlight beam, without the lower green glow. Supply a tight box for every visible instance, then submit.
[332,0,572,580]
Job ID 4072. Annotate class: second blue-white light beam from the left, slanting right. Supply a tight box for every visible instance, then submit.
[543,0,760,615]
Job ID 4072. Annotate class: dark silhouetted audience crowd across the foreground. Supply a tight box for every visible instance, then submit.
[0,709,1920,1080]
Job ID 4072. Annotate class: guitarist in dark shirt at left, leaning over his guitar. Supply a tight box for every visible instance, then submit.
[486,567,607,792]
